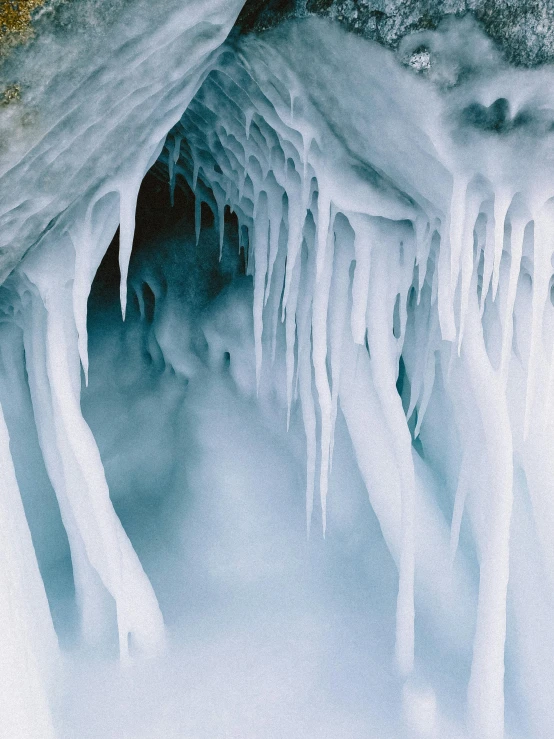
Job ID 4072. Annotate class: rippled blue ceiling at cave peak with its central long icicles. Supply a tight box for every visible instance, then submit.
[168,27,444,700]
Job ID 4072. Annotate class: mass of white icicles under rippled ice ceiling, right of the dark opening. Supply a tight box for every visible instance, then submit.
[153,26,554,739]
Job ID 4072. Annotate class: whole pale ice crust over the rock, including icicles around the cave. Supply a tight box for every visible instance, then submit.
[0,11,554,739]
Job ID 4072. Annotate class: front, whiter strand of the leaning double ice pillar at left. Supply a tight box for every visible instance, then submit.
[46,294,163,657]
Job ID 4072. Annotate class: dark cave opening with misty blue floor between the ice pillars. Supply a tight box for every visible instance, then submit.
[49,134,408,737]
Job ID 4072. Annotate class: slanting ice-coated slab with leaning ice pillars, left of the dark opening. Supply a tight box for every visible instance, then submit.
[0,0,245,739]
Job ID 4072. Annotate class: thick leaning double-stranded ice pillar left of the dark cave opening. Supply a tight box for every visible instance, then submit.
[15,232,164,659]
